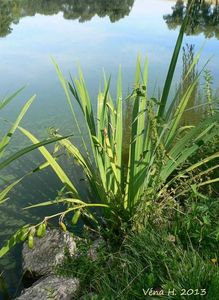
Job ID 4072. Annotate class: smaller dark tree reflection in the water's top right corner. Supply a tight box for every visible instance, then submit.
[164,0,219,39]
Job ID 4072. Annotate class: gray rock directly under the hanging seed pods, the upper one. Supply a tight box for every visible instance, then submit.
[22,229,77,276]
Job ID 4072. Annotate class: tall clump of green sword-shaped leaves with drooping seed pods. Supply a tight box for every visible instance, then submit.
[0,2,219,255]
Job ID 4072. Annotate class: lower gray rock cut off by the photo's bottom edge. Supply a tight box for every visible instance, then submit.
[16,275,80,300]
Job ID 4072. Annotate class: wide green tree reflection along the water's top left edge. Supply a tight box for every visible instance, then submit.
[0,0,134,37]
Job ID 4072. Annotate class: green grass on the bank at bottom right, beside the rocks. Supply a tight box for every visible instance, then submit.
[57,204,219,300]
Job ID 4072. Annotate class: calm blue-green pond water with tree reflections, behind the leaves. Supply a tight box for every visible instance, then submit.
[0,0,219,293]
